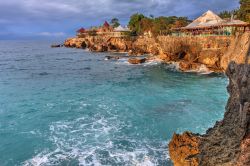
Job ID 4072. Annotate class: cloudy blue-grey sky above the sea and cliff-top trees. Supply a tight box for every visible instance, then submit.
[0,0,239,40]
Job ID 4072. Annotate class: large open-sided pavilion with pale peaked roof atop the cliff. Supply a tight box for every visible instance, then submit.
[172,10,250,36]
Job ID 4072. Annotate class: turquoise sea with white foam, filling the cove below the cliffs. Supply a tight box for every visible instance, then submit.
[0,41,227,166]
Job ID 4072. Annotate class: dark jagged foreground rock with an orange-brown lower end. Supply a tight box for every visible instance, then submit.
[169,62,250,166]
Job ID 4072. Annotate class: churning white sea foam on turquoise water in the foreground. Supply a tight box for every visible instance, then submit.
[23,112,169,166]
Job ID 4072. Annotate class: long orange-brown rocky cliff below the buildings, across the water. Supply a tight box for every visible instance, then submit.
[64,32,250,72]
